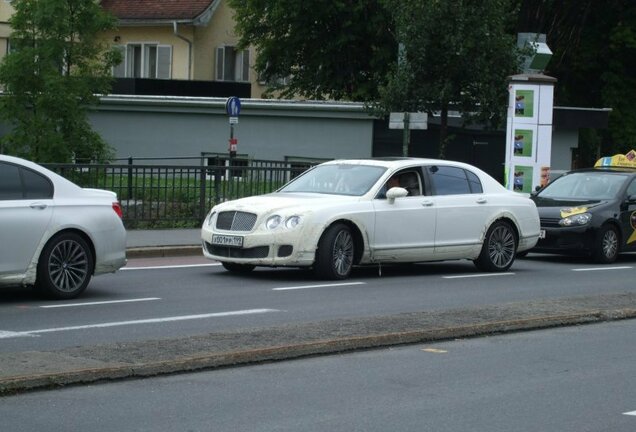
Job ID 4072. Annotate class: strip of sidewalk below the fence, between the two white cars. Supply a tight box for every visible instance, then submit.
[126,228,201,258]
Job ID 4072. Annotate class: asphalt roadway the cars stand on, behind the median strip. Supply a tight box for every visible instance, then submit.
[0,254,636,353]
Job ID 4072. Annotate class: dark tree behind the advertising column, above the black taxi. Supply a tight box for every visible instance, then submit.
[518,0,636,166]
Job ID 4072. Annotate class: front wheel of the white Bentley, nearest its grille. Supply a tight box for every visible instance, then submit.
[314,224,355,280]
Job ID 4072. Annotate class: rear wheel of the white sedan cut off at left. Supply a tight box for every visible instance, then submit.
[35,232,95,299]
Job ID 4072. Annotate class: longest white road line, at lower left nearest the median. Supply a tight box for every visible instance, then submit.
[0,309,280,339]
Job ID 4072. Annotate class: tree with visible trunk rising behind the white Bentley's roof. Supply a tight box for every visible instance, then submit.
[377,0,522,158]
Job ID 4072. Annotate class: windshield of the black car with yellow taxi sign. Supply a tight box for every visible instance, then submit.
[538,172,625,200]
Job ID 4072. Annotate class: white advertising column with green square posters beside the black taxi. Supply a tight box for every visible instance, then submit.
[505,74,556,193]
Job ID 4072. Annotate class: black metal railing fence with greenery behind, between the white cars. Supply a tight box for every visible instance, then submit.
[46,158,314,228]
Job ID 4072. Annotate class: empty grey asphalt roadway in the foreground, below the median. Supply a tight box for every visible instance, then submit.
[0,320,636,432]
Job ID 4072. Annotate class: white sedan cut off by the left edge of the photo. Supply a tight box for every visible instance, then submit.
[0,155,126,299]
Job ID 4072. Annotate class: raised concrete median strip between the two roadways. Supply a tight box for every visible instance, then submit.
[0,294,636,395]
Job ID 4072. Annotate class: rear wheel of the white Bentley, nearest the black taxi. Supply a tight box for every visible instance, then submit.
[474,220,517,272]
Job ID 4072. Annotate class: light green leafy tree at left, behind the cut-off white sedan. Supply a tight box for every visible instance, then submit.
[0,0,120,162]
